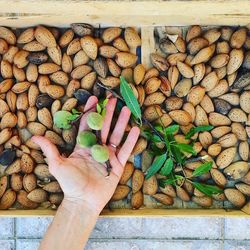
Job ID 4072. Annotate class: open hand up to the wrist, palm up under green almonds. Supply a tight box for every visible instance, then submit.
[32,96,140,214]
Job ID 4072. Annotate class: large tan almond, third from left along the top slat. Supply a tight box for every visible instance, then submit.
[34,26,56,48]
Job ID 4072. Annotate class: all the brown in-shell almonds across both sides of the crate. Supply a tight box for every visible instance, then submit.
[0,24,250,213]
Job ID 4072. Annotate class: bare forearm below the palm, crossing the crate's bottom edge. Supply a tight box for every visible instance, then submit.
[40,201,99,250]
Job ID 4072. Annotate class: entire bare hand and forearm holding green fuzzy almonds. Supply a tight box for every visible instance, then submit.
[36,96,140,250]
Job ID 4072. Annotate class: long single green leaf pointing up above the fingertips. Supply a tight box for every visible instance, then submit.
[120,76,142,124]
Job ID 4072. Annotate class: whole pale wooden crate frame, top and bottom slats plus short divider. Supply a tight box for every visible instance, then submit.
[0,0,250,217]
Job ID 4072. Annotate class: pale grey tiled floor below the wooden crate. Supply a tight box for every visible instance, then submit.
[0,217,250,250]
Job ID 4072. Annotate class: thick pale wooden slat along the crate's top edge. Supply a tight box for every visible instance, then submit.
[0,0,250,27]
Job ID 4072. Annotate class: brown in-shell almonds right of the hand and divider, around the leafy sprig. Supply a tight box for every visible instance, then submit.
[115,25,250,213]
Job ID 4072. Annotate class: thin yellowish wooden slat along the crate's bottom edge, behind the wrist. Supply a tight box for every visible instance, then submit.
[0,209,249,217]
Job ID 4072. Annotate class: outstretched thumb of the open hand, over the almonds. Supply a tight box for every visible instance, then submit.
[31,136,61,165]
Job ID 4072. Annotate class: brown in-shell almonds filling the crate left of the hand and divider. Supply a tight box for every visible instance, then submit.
[0,24,141,209]
